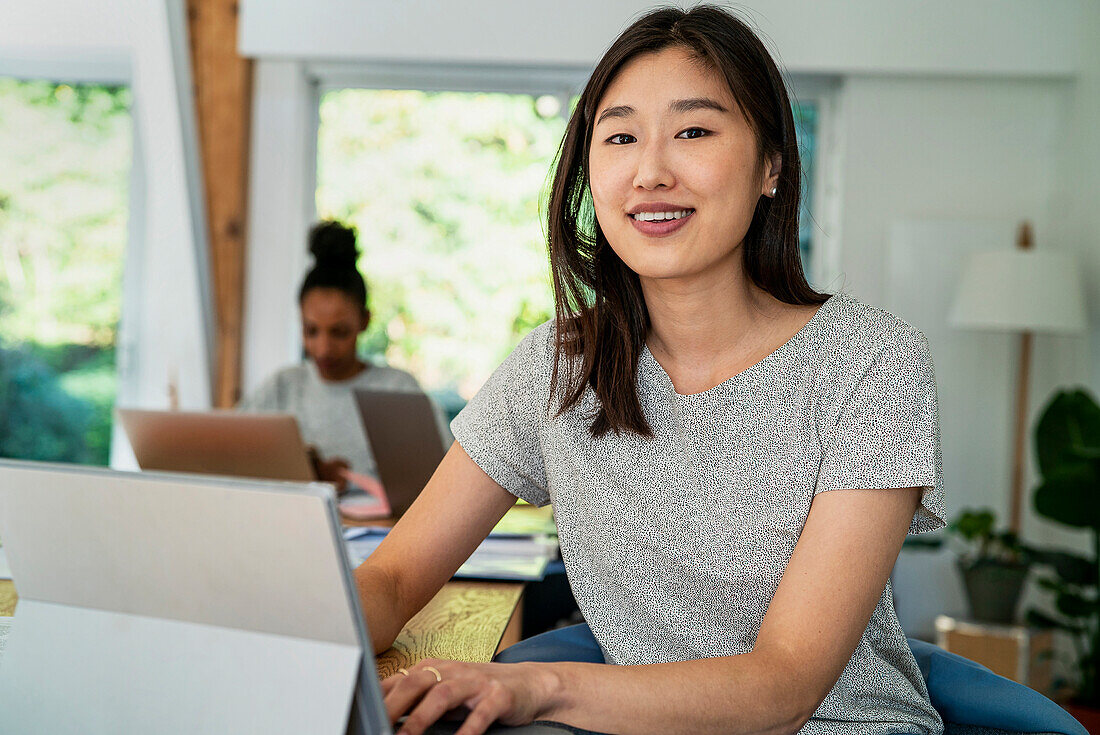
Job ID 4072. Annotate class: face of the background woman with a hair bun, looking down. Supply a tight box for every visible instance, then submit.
[301,288,369,381]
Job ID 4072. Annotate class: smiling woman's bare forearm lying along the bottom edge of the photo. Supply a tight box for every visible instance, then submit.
[540,654,818,735]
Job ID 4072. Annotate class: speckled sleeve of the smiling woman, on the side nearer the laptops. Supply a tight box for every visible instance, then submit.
[451,322,553,506]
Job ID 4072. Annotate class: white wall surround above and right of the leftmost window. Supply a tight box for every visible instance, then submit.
[0,0,210,435]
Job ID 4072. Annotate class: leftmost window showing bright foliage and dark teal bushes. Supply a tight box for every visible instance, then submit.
[0,78,133,464]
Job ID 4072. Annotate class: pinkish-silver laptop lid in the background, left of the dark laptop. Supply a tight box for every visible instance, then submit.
[118,408,317,482]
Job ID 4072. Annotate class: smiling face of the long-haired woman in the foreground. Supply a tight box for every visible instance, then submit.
[589,47,779,281]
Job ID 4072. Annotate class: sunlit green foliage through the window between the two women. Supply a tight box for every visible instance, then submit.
[316,89,565,398]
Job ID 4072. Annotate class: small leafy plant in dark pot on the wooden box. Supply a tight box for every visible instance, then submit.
[905,508,1032,624]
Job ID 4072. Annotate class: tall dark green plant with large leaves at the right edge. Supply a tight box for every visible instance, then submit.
[1027,390,1100,718]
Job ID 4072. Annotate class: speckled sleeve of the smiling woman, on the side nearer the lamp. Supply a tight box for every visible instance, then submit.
[815,330,945,534]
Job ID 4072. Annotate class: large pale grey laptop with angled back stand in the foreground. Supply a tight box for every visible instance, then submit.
[0,461,562,735]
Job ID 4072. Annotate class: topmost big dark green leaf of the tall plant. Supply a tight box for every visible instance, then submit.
[1035,390,1100,478]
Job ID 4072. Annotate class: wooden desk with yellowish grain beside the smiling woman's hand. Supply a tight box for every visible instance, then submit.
[0,580,524,677]
